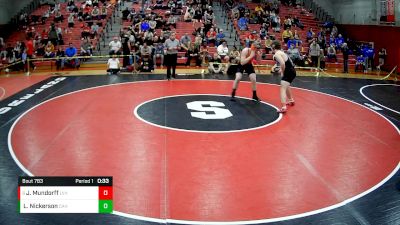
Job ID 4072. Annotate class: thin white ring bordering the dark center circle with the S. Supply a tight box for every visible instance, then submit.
[133,94,282,134]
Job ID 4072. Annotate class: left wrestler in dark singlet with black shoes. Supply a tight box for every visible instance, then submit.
[231,45,260,101]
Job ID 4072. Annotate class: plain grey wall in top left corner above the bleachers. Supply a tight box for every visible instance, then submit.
[0,0,32,25]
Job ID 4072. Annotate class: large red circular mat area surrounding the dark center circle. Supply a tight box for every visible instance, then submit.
[10,80,400,221]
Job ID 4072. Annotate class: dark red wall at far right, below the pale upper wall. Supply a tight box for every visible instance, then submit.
[339,25,400,71]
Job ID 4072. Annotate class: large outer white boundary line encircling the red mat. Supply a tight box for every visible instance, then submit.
[8,79,400,225]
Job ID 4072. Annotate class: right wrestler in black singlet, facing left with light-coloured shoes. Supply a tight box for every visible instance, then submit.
[273,41,296,113]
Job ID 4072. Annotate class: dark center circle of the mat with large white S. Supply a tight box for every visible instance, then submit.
[134,94,282,133]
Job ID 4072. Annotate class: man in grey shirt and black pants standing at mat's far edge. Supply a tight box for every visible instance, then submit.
[164,33,180,80]
